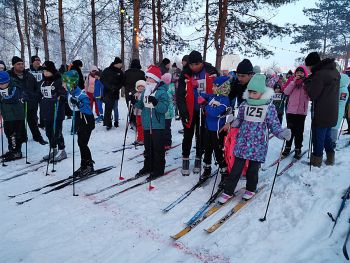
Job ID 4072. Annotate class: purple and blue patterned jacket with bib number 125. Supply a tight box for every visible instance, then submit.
[234,89,282,162]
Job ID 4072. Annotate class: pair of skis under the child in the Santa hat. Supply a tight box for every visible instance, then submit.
[92,167,179,204]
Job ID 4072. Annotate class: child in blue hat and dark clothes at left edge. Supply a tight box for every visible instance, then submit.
[0,71,26,162]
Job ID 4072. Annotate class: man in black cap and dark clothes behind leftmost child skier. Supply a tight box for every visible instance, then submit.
[8,56,47,145]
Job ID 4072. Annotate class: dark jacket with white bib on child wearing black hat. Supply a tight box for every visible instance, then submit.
[40,73,67,122]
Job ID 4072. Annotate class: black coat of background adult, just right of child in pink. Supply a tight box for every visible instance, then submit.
[101,63,124,100]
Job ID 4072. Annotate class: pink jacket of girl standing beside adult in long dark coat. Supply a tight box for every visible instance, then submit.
[284,79,310,115]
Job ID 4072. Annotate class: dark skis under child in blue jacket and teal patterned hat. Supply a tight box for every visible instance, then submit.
[8,166,115,205]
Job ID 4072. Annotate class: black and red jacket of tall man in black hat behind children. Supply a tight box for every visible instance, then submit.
[176,62,219,127]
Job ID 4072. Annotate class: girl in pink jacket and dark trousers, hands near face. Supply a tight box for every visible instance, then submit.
[282,66,309,159]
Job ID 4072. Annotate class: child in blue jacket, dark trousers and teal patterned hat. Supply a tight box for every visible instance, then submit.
[63,70,95,177]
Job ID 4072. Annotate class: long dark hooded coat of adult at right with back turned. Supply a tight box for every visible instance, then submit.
[305,58,340,128]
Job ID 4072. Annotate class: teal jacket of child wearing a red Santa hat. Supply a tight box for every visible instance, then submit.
[135,82,169,130]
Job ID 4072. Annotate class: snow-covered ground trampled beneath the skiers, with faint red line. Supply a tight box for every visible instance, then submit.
[0,101,350,263]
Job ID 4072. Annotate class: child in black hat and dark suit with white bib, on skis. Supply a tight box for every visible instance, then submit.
[40,61,67,162]
